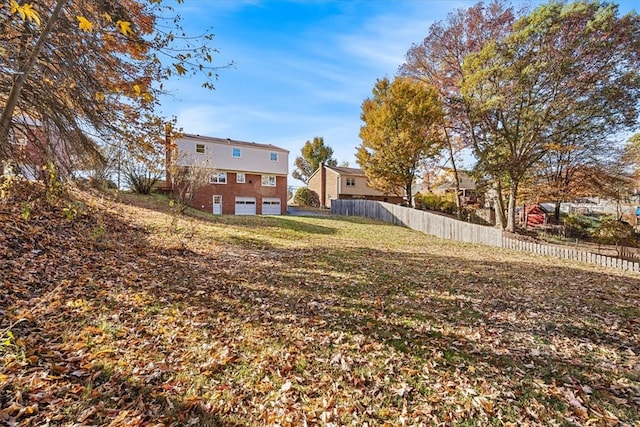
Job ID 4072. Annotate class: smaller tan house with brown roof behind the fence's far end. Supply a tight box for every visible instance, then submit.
[308,164,402,207]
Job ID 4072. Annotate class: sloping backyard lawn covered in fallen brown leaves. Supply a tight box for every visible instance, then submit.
[0,182,640,426]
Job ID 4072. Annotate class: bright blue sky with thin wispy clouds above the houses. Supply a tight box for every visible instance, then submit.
[162,0,640,186]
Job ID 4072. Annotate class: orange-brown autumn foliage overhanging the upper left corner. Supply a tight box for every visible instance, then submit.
[0,0,224,179]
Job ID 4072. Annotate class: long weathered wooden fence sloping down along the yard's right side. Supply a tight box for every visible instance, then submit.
[331,200,640,272]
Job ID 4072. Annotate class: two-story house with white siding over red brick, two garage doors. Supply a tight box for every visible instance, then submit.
[173,134,289,215]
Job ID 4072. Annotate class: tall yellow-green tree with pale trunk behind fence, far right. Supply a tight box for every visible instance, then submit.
[462,1,640,231]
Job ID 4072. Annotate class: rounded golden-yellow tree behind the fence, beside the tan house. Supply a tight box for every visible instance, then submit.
[356,77,443,204]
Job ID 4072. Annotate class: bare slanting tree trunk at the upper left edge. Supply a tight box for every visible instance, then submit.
[0,0,68,160]
